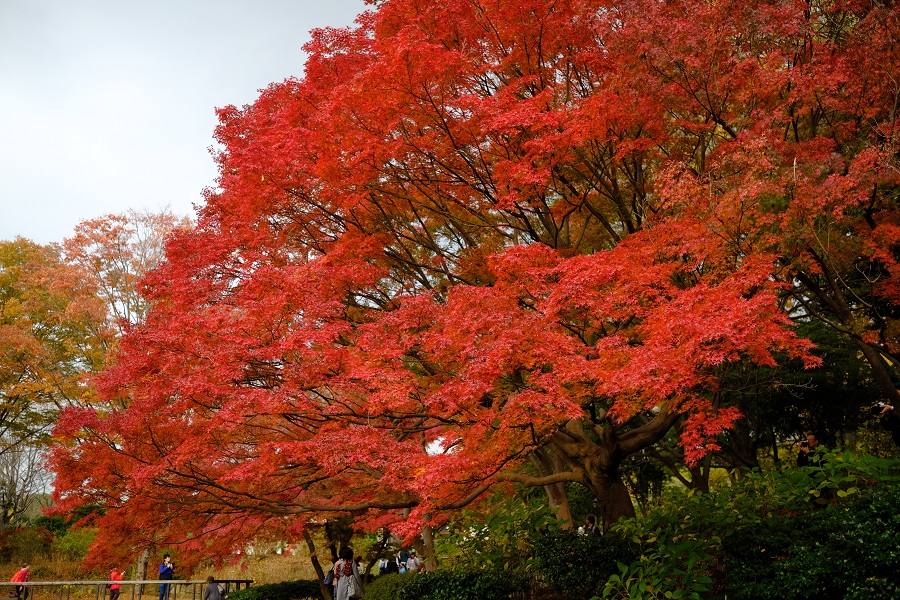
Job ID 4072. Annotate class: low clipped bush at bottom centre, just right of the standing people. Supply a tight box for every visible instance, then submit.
[397,569,528,600]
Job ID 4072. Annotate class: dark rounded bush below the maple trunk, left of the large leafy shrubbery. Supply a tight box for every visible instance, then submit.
[534,531,637,598]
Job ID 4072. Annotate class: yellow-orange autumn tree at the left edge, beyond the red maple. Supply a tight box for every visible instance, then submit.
[0,238,113,432]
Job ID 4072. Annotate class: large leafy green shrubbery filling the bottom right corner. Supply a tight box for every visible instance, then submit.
[603,452,900,600]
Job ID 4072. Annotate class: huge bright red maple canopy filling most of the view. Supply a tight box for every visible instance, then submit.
[54,0,897,564]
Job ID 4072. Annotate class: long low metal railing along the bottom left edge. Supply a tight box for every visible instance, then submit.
[0,579,253,600]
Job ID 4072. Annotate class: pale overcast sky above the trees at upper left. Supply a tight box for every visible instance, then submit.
[0,0,366,243]
